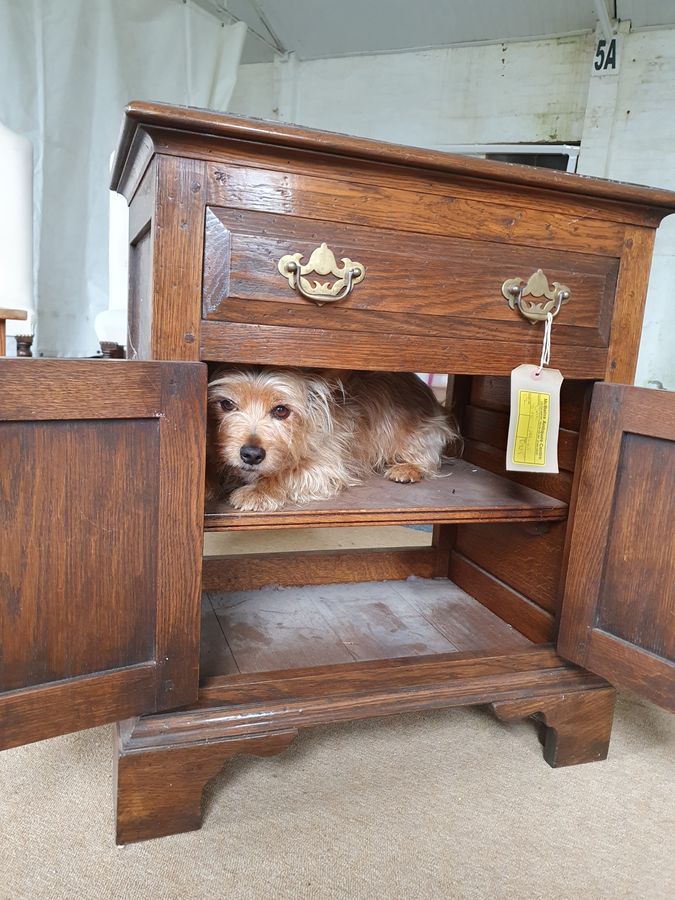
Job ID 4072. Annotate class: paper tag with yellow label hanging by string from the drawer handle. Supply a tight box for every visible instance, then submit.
[506,365,563,472]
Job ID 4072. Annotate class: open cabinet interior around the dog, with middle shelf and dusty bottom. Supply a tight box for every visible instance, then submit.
[200,376,591,684]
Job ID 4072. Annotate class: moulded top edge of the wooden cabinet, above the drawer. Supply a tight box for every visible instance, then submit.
[111,101,675,212]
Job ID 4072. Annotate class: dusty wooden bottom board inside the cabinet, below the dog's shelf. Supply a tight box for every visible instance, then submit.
[201,578,531,678]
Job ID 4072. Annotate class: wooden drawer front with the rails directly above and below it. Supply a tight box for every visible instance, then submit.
[202,166,623,378]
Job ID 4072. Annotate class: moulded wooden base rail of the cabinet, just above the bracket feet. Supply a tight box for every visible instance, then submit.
[126,646,607,752]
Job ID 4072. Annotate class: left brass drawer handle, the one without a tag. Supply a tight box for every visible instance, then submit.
[277,243,366,306]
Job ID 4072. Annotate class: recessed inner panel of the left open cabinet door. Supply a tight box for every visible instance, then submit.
[0,419,159,691]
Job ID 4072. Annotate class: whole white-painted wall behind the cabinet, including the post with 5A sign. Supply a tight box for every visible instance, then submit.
[231,23,675,390]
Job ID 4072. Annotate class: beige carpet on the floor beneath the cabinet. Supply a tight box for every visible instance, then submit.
[0,528,675,900]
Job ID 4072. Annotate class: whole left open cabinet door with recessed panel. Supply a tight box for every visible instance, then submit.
[0,359,206,749]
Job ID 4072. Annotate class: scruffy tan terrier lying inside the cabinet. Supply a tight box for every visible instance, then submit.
[206,367,459,511]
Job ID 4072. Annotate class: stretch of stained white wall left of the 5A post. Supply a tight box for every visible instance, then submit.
[230,35,593,142]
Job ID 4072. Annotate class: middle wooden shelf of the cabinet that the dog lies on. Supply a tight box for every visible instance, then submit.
[204,460,567,531]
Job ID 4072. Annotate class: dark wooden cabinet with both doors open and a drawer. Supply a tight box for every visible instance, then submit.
[0,104,675,842]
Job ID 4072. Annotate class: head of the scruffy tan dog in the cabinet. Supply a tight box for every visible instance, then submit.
[209,369,331,481]
